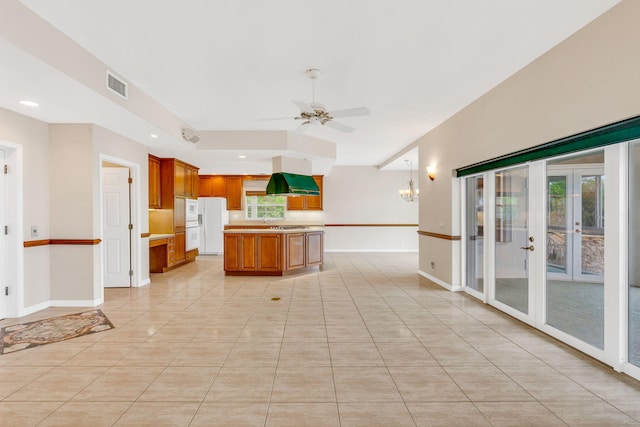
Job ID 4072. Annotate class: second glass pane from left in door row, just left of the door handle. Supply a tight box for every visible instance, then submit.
[494,167,534,314]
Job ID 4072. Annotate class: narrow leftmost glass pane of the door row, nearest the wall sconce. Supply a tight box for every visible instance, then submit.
[466,176,484,292]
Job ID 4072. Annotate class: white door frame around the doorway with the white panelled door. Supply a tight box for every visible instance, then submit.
[98,153,143,300]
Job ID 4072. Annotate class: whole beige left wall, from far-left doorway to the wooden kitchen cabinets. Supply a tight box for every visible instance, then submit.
[0,114,149,310]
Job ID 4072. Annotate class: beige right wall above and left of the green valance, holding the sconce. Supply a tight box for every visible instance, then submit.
[419,0,640,283]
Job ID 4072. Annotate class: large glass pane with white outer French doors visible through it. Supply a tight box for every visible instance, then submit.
[545,151,604,349]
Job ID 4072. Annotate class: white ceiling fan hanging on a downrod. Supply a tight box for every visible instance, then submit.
[293,68,369,132]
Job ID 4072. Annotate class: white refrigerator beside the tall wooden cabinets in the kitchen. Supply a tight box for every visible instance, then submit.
[198,197,229,255]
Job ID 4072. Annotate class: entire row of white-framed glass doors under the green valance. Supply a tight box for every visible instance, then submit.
[462,139,640,379]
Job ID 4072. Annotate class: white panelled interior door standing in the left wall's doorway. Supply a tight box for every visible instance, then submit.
[102,167,132,287]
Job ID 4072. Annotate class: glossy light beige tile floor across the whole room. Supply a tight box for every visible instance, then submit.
[0,253,640,427]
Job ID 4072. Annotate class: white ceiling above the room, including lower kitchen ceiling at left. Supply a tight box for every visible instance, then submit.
[0,0,618,173]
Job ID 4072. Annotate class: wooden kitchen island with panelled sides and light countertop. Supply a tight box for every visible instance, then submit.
[224,226,324,276]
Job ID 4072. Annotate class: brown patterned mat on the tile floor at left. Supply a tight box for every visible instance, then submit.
[0,310,114,354]
